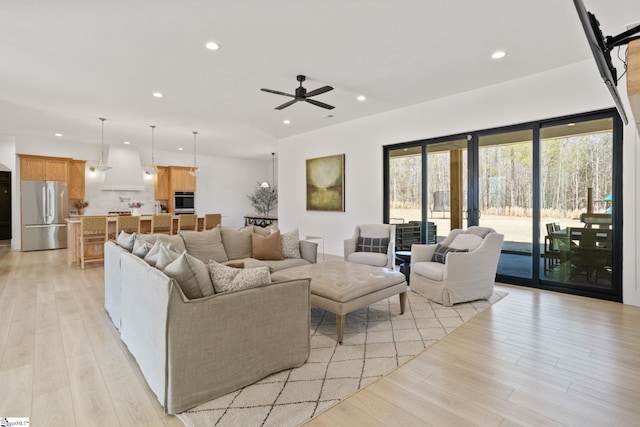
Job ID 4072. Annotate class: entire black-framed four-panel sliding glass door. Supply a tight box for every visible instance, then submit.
[384,110,622,301]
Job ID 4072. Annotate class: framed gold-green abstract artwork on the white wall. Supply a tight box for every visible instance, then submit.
[307,154,344,212]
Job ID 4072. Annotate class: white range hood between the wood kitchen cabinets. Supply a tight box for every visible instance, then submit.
[102,145,144,191]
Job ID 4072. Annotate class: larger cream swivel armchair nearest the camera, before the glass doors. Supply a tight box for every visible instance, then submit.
[410,226,504,306]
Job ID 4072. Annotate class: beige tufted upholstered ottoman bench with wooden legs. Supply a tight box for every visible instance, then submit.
[271,261,408,344]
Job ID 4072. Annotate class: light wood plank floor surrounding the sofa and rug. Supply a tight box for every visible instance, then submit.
[0,247,640,427]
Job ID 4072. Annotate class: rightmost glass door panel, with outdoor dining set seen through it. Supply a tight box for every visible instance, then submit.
[540,118,613,290]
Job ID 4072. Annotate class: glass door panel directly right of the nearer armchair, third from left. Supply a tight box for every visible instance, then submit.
[477,129,533,279]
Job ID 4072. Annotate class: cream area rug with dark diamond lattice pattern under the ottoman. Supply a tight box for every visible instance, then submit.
[178,291,507,427]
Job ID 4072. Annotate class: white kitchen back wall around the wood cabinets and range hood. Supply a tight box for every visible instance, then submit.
[10,137,272,249]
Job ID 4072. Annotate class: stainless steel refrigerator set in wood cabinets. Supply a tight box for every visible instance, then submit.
[22,181,69,251]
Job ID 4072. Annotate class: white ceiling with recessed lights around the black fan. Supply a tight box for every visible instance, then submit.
[0,0,640,158]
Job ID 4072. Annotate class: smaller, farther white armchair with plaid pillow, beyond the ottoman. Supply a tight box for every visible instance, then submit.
[344,224,396,269]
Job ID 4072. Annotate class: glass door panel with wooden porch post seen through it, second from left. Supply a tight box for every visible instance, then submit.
[426,139,468,243]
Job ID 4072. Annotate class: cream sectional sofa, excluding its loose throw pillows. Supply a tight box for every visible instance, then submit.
[105,226,316,413]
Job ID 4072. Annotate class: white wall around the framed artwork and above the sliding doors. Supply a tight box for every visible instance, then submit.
[278,60,640,305]
